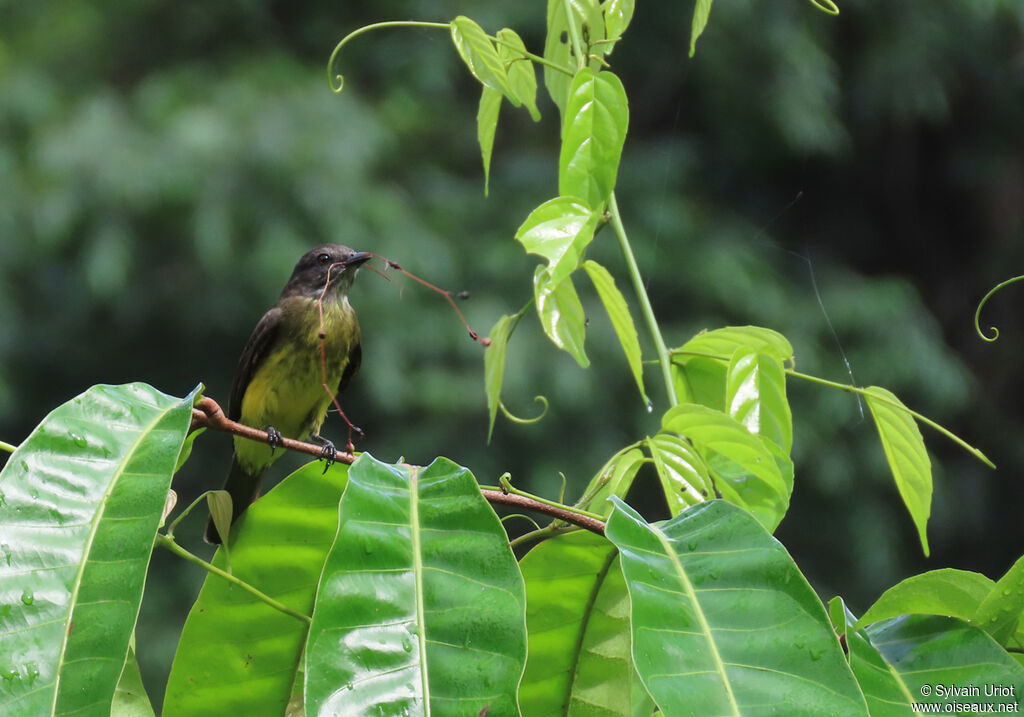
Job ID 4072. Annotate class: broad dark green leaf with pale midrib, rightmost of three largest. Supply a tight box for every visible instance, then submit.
[606,499,867,716]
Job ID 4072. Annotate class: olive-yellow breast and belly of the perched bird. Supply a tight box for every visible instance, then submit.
[234,297,359,468]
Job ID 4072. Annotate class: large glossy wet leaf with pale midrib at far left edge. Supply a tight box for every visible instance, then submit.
[0,383,193,717]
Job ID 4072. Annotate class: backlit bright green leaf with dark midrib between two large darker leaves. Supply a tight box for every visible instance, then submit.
[519,528,653,717]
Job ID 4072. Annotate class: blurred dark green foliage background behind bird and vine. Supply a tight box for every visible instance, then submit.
[0,0,1024,702]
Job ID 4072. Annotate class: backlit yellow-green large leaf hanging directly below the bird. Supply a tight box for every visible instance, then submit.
[163,461,348,717]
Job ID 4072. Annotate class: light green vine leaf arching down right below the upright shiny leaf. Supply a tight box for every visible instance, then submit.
[662,404,793,530]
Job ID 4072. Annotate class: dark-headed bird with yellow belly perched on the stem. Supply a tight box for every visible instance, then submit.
[206,244,370,544]
